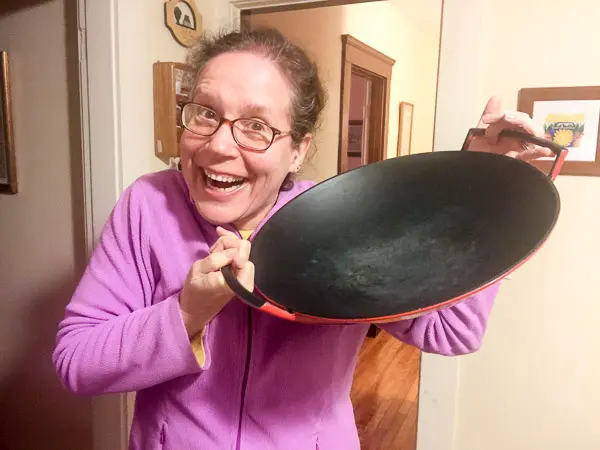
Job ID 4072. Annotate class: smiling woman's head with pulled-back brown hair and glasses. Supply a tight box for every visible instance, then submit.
[181,31,325,229]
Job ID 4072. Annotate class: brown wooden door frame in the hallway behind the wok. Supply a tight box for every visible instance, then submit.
[338,34,396,173]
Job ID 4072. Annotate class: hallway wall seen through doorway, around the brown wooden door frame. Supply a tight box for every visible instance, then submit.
[251,0,441,181]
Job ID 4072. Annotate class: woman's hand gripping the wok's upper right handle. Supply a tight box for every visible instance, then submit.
[468,97,554,161]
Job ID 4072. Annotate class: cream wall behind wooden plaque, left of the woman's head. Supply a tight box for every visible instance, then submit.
[116,0,230,187]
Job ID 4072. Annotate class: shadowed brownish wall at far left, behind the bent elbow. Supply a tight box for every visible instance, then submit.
[0,0,92,450]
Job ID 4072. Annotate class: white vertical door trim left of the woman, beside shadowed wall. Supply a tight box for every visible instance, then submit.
[77,0,129,450]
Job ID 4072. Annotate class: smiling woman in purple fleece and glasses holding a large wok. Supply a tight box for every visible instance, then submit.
[54,30,545,450]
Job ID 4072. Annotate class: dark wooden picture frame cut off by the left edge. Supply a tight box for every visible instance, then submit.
[0,51,18,194]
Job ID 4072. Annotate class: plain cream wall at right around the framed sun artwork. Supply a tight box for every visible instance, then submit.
[436,0,600,450]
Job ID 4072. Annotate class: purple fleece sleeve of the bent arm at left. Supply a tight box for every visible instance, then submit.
[53,183,203,395]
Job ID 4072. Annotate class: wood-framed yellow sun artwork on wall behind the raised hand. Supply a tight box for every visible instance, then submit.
[517,86,600,176]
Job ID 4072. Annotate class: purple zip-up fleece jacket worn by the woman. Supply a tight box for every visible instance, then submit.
[53,170,498,450]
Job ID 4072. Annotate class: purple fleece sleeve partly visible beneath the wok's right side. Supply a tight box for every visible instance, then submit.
[377,283,499,356]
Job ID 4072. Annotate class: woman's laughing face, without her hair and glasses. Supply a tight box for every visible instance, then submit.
[181,53,310,229]
